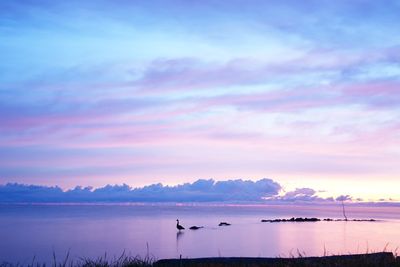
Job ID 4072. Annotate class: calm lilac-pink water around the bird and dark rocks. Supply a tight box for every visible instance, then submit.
[0,205,400,263]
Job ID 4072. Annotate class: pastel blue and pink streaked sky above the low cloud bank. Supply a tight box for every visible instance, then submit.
[0,0,400,200]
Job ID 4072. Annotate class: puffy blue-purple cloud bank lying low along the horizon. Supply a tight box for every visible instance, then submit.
[0,178,361,203]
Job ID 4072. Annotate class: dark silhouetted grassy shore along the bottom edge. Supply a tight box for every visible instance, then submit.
[0,252,400,267]
